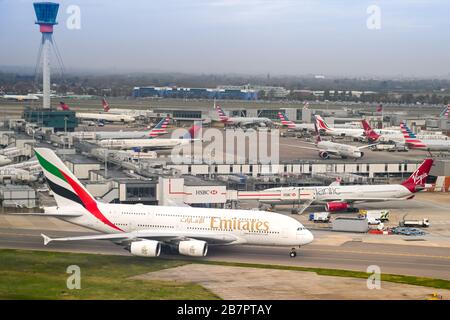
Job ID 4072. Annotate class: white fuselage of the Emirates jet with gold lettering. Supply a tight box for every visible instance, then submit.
[47,204,313,246]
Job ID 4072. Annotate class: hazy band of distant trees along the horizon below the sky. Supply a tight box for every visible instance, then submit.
[0,72,450,104]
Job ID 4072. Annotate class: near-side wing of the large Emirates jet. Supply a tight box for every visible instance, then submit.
[41,230,240,245]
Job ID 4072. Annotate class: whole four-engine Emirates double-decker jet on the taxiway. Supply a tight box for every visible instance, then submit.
[22,148,313,257]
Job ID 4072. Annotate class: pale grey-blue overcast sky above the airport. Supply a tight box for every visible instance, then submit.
[0,0,450,77]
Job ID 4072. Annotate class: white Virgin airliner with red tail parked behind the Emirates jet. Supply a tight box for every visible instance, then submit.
[258,158,433,212]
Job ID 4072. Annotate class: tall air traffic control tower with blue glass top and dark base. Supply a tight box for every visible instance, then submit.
[24,2,78,131]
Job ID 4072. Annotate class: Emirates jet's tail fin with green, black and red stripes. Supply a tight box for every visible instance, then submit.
[34,148,123,231]
